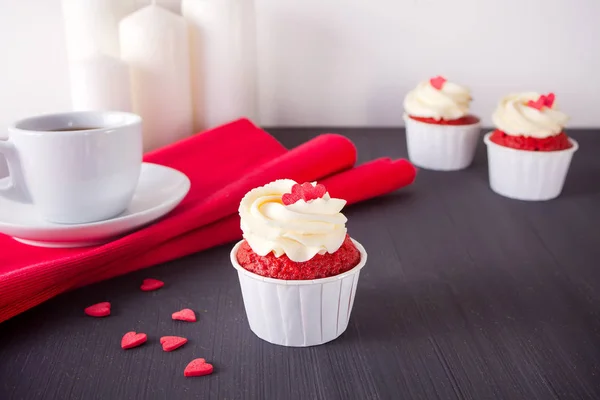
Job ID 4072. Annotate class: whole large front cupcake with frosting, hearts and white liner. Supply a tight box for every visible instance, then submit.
[231,179,367,347]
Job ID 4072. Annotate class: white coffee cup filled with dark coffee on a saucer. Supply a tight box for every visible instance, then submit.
[0,111,143,224]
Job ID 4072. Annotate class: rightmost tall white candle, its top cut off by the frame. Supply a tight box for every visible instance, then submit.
[181,0,257,129]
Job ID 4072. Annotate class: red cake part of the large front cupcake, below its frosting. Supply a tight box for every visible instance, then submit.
[237,235,360,281]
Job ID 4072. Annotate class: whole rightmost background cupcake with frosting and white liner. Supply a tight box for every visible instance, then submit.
[484,92,578,200]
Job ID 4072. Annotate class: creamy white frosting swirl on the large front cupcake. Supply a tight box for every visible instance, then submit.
[239,179,347,262]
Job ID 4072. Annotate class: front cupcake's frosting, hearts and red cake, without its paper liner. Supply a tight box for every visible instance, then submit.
[237,180,360,280]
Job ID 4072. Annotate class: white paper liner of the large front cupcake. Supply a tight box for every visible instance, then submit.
[231,240,367,347]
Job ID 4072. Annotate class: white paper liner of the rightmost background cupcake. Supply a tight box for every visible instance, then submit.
[483,132,579,201]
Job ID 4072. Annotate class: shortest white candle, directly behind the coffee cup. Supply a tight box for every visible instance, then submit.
[71,55,131,111]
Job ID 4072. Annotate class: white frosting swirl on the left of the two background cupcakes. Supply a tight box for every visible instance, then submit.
[404,81,471,120]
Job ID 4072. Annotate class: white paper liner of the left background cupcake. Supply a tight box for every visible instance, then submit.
[404,115,481,171]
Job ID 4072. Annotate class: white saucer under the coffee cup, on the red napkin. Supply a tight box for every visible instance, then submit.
[0,163,190,247]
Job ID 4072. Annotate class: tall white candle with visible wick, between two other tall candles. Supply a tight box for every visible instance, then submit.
[119,5,193,151]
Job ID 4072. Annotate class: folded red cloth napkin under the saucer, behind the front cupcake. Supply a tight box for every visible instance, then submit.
[0,120,415,322]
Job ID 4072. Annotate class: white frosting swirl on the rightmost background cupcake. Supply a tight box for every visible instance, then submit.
[492,92,569,139]
